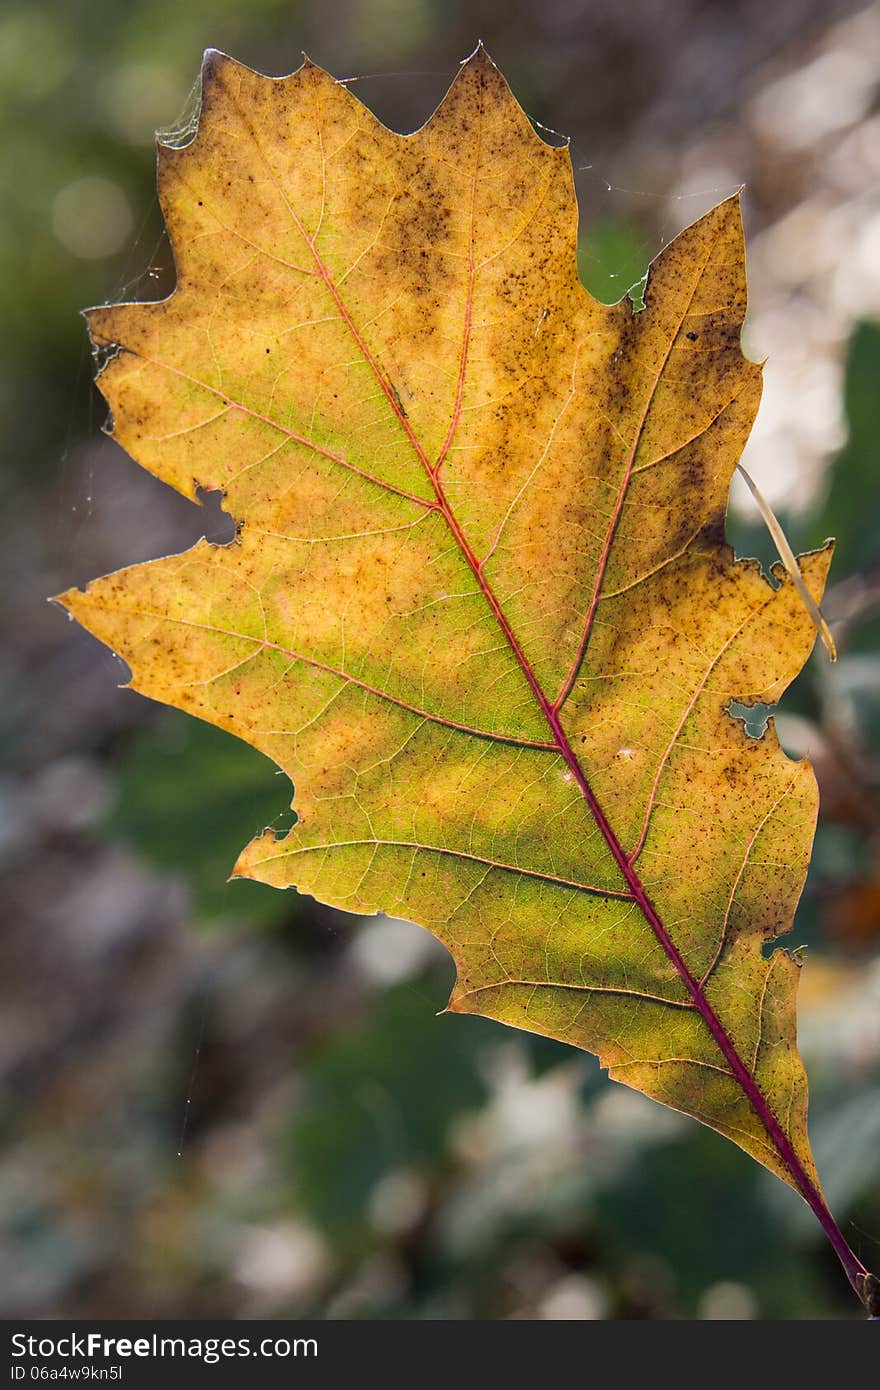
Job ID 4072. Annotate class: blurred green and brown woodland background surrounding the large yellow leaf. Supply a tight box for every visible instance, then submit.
[0,0,880,1319]
